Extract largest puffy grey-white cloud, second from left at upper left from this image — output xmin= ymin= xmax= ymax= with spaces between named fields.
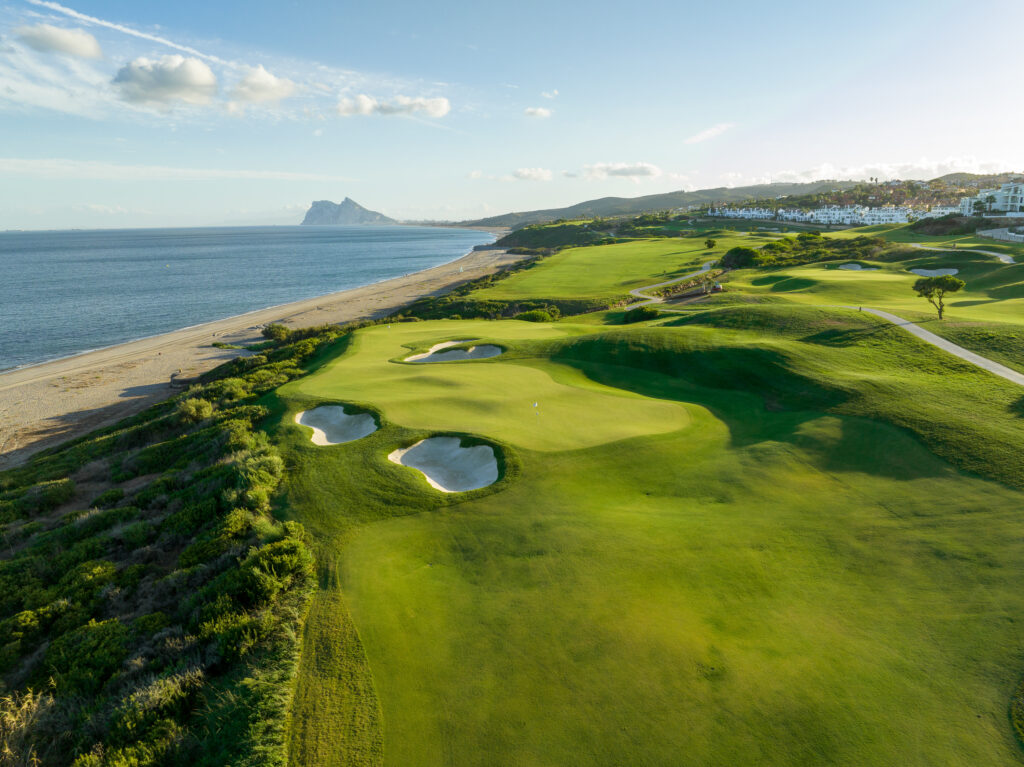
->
xmin=113 ymin=54 xmax=217 ymax=103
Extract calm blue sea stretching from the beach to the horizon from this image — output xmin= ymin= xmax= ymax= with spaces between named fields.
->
xmin=0 ymin=226 xmax=494 ymax=370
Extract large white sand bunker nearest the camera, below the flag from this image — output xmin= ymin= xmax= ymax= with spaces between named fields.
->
xmin=387 ymin=437 xmax=498 ymax=493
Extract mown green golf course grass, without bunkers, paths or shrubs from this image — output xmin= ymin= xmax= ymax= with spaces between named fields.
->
xmin=268 ymin=223 xmax=1024 ymax=767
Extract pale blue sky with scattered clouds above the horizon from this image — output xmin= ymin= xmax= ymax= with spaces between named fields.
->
xmin=0 ymin=0 xmax=1024 ymax=229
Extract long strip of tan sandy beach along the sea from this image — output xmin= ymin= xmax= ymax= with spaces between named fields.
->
xmin=0 ymin=242 xmax=523 ymax=469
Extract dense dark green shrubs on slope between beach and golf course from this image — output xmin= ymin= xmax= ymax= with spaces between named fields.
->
xmin=0 ymin=321 xmax=327 ymax=767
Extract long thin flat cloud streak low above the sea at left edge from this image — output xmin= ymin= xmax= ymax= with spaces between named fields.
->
xmin=0 ymin=158 xmax=352 ymax=181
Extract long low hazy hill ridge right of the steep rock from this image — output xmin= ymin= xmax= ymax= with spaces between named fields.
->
xmin=460 ymin=180 xmax=858 ymax=228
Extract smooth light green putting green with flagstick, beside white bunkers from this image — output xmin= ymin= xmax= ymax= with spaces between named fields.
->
xmin=282 ymin=321 xmax=689 ymax=451
